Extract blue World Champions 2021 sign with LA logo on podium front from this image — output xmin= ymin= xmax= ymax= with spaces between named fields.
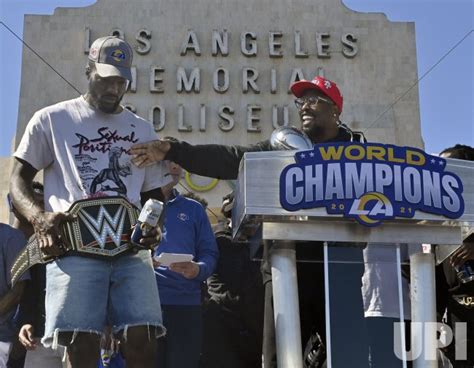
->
xmin=280 ymin=143 xmax=464 ymax=226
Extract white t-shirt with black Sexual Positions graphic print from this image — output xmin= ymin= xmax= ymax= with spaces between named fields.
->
xmin=14 ymin=97 xmax=171 ymax=211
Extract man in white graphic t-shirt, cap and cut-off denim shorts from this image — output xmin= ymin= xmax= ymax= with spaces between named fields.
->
xmin=10 ymin=36 xmax=170 ymax=368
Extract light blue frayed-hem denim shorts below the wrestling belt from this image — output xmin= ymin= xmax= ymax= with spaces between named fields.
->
xmin=42 ymin=250 xmax=166 ymax=349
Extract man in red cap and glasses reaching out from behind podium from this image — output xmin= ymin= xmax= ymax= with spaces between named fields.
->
xmin=131 ymin=76 xmax=368 ymax=368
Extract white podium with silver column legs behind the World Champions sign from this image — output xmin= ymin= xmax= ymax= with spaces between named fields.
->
xmin=232 ymin=151 xmax=474 ymax=368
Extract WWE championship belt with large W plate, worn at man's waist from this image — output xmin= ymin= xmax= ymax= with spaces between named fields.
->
xmin=11 ymin=197 xmax=139 ymax=285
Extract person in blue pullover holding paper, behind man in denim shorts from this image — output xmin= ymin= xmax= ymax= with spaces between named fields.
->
xmin=154 ymin=157 xmax=219 ymax=368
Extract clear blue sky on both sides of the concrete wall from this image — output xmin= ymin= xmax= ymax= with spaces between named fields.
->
xmin=0 ymin=0 xmax=474 ymax=156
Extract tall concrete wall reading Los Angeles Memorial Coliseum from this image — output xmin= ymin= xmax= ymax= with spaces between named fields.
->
xmin=13 ymin=0 xmax=423 ymax=211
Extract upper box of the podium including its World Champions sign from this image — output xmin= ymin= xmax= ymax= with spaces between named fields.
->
xmin=233 ymin=143 xmax=474 ymax=244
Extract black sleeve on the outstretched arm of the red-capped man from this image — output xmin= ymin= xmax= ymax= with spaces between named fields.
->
xmin=166 ymin=140 xmax=271 ymax=180
